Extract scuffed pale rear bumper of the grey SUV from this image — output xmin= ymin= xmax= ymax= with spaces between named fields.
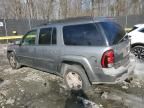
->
xmin=92 ymin=61 xmax=135 ymax=84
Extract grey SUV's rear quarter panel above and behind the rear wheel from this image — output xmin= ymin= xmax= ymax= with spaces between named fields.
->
xmin=61 ymin=46 xmax=110 ymax=81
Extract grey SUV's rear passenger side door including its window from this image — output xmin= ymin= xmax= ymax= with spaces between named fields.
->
xmin=35 ymin=27 xmax=59 ymax=72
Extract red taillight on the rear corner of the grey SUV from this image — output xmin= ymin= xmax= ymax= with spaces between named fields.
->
xmin=101 ymin=50 xmax=114 ymax=68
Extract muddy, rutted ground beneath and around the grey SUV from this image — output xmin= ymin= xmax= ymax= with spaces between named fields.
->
xmin=0 ymin=44 xmax=144 ymax=108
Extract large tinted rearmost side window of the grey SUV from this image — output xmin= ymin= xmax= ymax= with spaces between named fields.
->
xmin=63 ymin=24 xmax=106 ymax=46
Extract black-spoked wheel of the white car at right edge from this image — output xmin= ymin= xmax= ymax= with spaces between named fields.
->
xmin=131 ymin=45 xmax=144 ymax=61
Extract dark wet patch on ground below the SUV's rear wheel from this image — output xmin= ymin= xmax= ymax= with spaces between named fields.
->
xmin=65 ymin=90 xmax=88 ymax=108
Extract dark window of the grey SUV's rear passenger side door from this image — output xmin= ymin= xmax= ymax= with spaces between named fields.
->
xmin=39 ymin=28 xmax=56 ymax=45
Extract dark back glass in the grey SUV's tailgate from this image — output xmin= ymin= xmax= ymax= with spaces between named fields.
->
xmin=100 ymin=22 xmax=125 ymax=45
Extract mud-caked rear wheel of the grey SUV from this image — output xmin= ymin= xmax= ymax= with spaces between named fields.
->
xmin=64 ymin=65 xmax=91 ymax=90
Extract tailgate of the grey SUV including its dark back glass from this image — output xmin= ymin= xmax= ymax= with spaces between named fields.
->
xmin=100 ymin=22 xmax=130 ymax=67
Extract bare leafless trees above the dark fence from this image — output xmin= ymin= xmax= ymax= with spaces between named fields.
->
xmin=0 ymin=0 xmax=144 ymax=20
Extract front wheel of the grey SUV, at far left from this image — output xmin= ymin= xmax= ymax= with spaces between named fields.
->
xmin=8 ymin=52 xmax=21 ymax=69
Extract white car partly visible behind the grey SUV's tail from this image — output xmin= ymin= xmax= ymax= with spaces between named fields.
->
xmin=128 ymin=24 xmax=144 ymax=60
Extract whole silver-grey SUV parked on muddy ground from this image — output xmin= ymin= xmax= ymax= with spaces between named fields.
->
xmin=7 ymin=17 xmax=134 ymax=89
